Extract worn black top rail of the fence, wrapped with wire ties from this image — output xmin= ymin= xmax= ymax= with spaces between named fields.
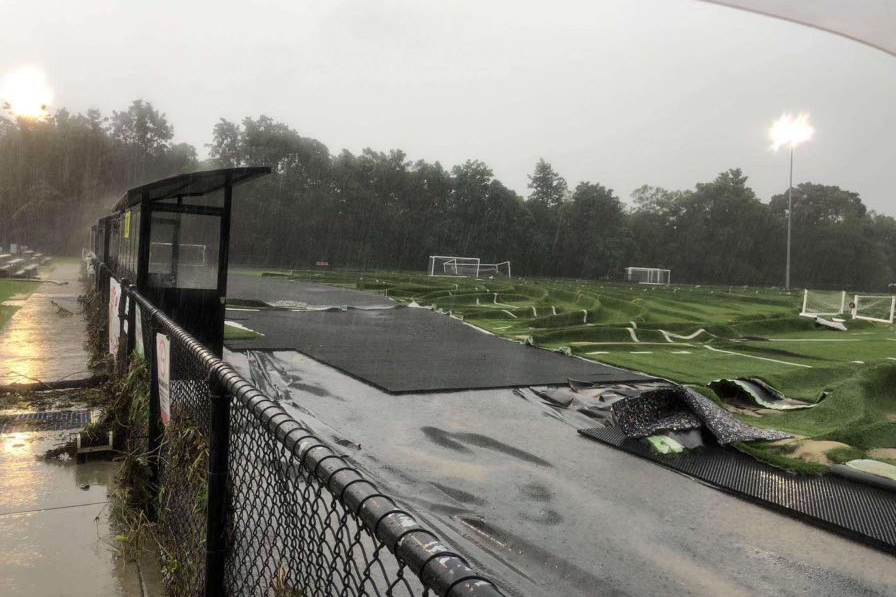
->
xmin=93 ymin=259 xmax=503 ymax=597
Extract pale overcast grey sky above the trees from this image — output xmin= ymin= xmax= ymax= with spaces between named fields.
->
xmin=0 ymin=0 xmax=896 ymax=215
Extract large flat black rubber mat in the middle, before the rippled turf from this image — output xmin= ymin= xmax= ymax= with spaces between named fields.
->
xmin=225 ymin=308 xmax=651 ymax=393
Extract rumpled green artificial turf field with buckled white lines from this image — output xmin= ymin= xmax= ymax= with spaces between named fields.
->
xmin=266 ymin=271 xmax=896 ymax=473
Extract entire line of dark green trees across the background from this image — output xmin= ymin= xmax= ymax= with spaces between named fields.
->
xmin=0 ymin=100 xmax=896 ymax=290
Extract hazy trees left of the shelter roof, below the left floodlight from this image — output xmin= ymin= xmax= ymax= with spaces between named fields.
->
xmin=0 ymin=101 xmax=197 ymax=252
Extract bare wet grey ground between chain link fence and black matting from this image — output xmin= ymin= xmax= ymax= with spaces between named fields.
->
xmin=227 ymin=352 xmax=896 ymax=596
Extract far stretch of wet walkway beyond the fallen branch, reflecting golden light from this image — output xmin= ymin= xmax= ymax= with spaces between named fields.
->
xmin=0 ymin=259 xmax=91 ymax=386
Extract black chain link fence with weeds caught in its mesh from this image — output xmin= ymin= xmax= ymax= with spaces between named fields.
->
xmin=94 ymin=262 xmax=501 ymax=597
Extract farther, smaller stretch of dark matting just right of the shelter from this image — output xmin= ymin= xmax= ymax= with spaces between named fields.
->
xmin=227 ymin=274 xmax=395 ymax=308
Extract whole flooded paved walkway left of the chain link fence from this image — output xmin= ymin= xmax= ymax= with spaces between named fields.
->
xmin=0 ymin=261 xmax=161 ymax=597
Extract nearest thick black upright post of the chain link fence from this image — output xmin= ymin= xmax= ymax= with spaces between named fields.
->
xmin=205 ymin=370 xmax=230 ymax=597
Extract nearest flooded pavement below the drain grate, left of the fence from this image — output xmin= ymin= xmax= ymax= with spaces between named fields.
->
xmin=0 ymin=411 xmax=160 ymax=597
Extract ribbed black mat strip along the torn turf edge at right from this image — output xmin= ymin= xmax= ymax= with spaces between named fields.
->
xmin=579 ymin=427 xmax=896 ymax=553
